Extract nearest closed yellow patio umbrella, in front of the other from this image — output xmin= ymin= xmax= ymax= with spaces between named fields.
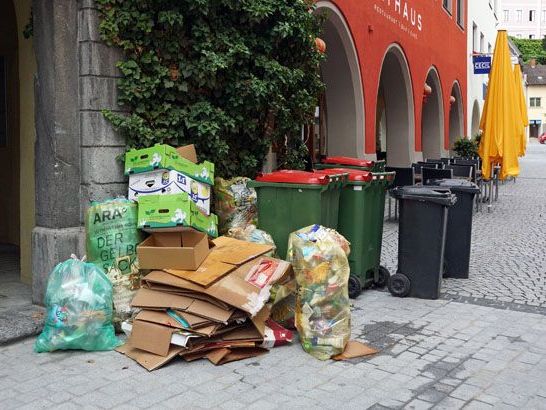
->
xmin=478 ymin=30 xmax=522 ymax=179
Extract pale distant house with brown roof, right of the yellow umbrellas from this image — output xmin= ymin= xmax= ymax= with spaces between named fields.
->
xmin=523 ymin=60 xmax=546 ymax=138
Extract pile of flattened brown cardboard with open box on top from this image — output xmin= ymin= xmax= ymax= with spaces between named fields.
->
xmin=117 ymin=235 xmax=292 ymax=370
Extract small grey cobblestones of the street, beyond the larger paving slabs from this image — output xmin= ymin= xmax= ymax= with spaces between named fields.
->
xmin=383 ymin=143 xmax=546 ymax=313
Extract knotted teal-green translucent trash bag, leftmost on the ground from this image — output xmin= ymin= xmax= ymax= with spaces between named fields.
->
xmin=34 ymin=259 xmax=120 ymax=353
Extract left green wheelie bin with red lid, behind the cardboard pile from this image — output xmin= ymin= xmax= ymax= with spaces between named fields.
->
xmin=248 ymin=170 xmax=347 ymax=258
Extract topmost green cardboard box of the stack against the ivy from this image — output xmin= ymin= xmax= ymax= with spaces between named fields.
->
xmin=125 ymin=144 xmax=214 ymax=185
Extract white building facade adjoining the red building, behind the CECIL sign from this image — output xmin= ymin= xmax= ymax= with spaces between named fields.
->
xmin=466 ymin=0 xmax=498 ymax=137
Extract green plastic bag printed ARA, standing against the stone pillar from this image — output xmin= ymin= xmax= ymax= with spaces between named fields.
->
xmin=85 ymin=198 xmax=144 ymax=272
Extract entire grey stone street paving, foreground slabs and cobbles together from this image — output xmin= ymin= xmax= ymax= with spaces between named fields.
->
xmin=0 ymin=146 xmax=546 ymax=409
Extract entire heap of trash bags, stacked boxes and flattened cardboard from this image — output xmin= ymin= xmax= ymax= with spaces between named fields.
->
xmin=35 ymin=145 xmax=373 ymax=371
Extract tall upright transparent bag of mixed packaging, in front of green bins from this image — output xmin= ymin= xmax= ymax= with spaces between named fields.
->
xmin=288 ymin=225 xmax=351 ymax=360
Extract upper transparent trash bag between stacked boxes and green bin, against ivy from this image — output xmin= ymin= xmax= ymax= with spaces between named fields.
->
xmin=214 ymin=177 xmax=258 ymax=235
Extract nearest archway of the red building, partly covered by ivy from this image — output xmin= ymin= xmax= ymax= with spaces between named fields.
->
xmin=316 ymin=1 xmax=365 ymax=157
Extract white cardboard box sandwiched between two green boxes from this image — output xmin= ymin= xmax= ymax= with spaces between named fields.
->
xmin=128 ymin=169 xmax=212 ymax=215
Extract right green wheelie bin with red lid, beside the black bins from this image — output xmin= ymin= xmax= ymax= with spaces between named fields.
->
xmin=316 ymin=168 xmax=395 ymax=298
